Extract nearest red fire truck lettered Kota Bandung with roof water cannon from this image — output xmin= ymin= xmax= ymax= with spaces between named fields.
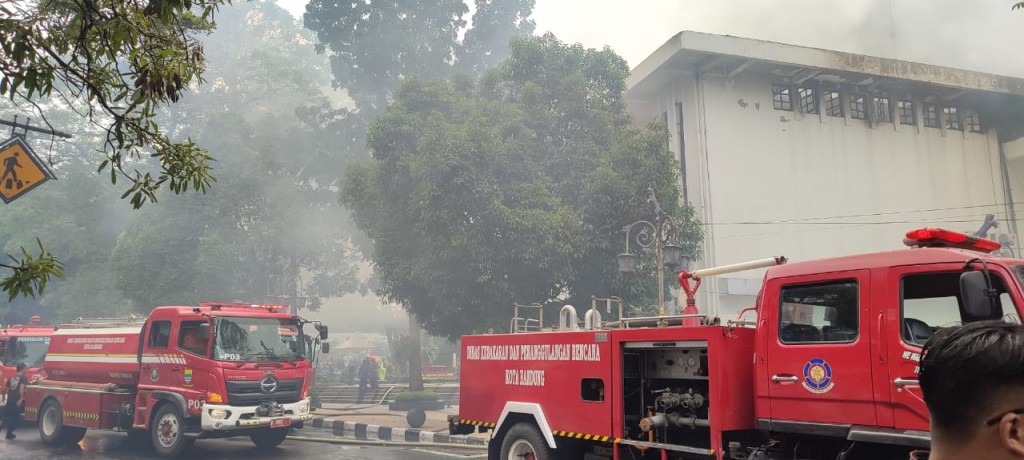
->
xmin=450 ymin=228 xmax=1024 ymax=460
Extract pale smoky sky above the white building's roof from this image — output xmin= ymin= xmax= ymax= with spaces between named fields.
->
xmin=278 ymin=0 xmax=1024 ymax=77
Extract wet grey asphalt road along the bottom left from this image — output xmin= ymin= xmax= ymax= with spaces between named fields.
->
xmin=0 ymin=425 xmax=486 ymax=460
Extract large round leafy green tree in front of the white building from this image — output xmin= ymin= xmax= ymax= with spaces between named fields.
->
xmin=342 ymin=35 xmax=701 ymax=338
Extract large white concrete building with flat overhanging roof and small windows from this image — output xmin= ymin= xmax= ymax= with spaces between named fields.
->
xmin=627 ymin=32 xmax=1024 ymax=318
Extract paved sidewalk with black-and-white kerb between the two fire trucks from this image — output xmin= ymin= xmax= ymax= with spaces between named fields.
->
xmin=307 ymin=404 xmax=490 ymax=446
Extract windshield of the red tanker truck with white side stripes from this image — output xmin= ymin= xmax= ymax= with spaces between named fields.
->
xmin=213 ymin=317 xmax=306 ymax=363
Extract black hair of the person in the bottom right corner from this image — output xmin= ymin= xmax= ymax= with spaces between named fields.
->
xmin=920 ymin=322 xmax=1024 ymax=442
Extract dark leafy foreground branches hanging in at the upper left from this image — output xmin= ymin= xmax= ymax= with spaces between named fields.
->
xmin=0 ymin=0 xmax=228 ymax=298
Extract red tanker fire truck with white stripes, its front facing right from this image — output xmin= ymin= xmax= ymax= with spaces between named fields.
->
xmin=25 ymin=302 xmax=327 ymax=457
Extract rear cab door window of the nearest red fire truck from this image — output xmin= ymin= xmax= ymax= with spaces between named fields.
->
xmin=778 ymin=281 xmax=860 ymax=344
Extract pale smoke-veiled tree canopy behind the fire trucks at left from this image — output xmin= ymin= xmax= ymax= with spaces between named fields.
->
xmin=0 ymin=2 xmax=358 ymax=323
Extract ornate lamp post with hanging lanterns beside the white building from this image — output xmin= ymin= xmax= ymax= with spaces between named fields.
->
xmin=617 ymin=187 xmax=687 ymax=317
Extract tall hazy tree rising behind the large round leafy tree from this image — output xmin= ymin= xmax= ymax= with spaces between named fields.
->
xmin=303 ymin=0 xmax=534 ymax=391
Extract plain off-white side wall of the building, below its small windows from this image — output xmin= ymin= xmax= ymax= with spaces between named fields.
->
xmin=631 ymin=70 xmax=1007 ymax=318
